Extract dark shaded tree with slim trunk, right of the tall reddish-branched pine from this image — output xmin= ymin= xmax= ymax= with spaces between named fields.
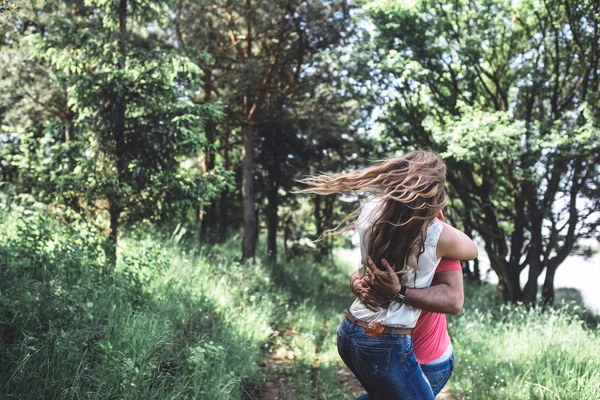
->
xmin=256 ymin=65 xmax=364 ymax=259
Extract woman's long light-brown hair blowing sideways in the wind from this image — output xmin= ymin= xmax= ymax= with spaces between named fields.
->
xmin=300 ymin=150 xmax=446 ymax=273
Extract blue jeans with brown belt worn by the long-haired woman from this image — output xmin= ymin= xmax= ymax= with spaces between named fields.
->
xmin=337 ymin=318 xmax=434 ymax=400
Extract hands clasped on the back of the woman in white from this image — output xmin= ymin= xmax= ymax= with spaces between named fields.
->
xmin=351 ymin=257 xmax=400 ymax=312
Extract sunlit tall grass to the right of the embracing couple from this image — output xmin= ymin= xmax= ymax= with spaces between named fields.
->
xmin=448 ymin=285 xmax=600 ymax=400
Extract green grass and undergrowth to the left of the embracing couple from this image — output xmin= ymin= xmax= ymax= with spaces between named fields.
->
xmin=0 ymin=204 xmax=348 ymax=400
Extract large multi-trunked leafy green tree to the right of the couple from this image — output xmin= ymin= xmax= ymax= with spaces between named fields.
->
xmin=367 ymin=0 xmax=600 ymax=303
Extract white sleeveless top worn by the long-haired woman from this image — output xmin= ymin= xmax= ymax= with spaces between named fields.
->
xmin=350 ymin=198 xmax=443 ymax=328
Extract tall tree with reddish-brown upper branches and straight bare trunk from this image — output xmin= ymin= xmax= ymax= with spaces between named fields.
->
xmin=175 ymin=0 xmax=349 ymax=259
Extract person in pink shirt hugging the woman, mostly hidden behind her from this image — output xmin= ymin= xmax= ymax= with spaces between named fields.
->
xmin=351 ymin=250 xmax=464 ymax=400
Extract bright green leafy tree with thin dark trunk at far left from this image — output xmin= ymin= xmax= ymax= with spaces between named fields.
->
xmin=3 ymin=0 xmax=226 ymax=266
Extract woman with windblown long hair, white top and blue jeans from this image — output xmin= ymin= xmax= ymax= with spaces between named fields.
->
xmin=302 ymin=151 xmax=477 ymax=400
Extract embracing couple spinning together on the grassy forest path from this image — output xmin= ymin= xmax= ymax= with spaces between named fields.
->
xmin=303 ymin=151 xmax=477 ymax=400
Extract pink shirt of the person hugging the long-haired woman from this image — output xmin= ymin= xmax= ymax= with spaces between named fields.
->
xmin=412 ymin=258 xmax=462 ymax=364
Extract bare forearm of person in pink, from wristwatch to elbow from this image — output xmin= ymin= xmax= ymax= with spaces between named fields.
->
xmin=404 ymin=283 xmax=464 ymax=315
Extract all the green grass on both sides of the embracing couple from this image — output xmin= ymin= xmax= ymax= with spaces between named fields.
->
xmin=0 ymin=205 xmax=600 ymax=400
